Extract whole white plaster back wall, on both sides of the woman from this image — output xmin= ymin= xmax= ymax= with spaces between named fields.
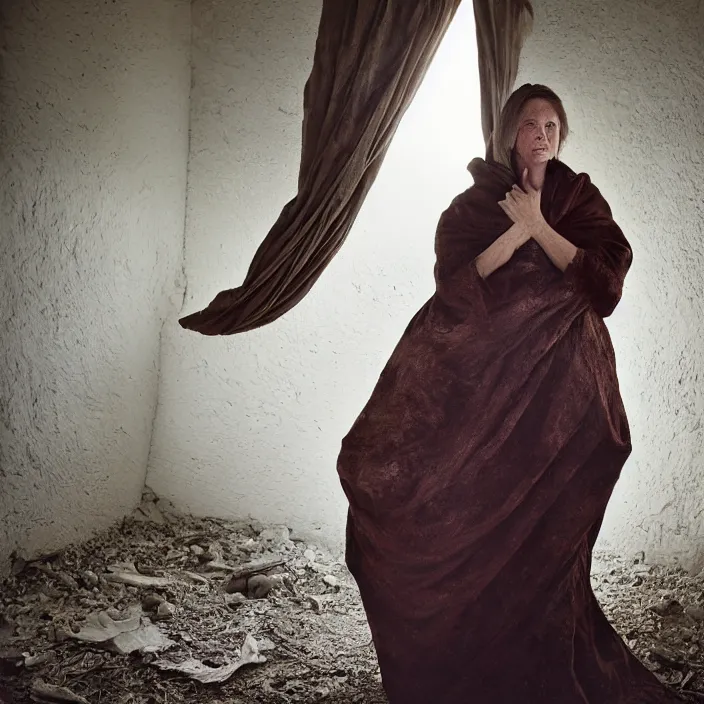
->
xmin=149 ymin=0 xmax=704 ymax=567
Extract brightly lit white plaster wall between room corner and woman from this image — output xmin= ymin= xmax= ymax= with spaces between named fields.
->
xmin=148 ymin=0 xmax=481 ymax=544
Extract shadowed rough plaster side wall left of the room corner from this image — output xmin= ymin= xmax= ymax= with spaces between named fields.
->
xmin=0 ymin=0 xmax=190 ymax=570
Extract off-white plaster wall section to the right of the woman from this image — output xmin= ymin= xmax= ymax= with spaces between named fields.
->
xmin=521 ymin=0 xmax=704 ymax=569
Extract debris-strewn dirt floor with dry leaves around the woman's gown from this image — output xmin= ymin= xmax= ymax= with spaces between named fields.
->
xmin=0 ymin=494 xmax=704 ymax=704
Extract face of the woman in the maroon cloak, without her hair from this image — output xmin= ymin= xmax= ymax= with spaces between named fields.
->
xmin=515 ymin=98 xmax=560 ymax=169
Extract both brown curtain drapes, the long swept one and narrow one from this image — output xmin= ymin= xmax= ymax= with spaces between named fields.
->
xmin=179 ymin=0 xmax=532 ymax=335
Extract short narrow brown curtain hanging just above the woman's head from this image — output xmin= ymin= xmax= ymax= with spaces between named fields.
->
xmin=474 ymin=0 xmax=533 ymax=158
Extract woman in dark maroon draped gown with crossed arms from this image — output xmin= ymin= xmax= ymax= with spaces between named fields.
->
xmin=338 ymin=84 xmax=680 ymax=704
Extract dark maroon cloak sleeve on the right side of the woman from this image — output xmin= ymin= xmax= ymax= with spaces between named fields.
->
xmin=555 ymin=176 xmax=633 ymax=318
